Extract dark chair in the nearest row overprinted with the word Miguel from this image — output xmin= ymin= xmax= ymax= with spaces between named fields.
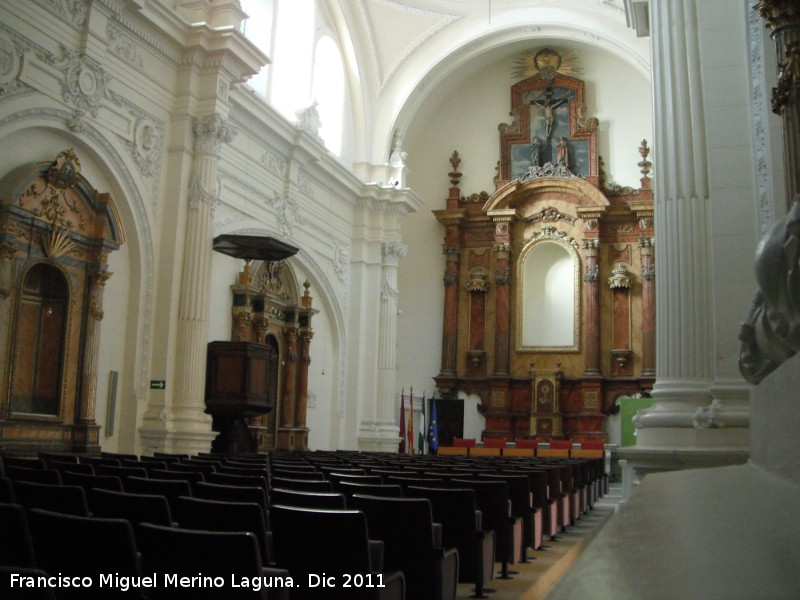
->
xmin=28 ymin=509 xmax=145 ymax=600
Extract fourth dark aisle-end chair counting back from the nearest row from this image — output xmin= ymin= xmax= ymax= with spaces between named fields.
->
xmin=450 ymin=479 xmax=522 ymax=579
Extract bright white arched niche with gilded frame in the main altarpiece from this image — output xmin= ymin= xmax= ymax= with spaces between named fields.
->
xmin=516 ymin=238 xmax=581 ymax=352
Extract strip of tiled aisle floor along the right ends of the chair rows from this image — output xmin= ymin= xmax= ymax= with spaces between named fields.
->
xmin=456 ymin=485 xmax=621 ymax=600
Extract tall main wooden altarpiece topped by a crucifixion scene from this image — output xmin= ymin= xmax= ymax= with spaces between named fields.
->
xmin=434 ymin=61 xmax=655 ymax=441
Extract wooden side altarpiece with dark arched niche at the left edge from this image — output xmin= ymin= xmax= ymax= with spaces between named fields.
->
xmin=0 ymin=149 xmax=125 ymax=453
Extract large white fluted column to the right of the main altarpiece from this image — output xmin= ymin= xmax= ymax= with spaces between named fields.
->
xmin=635 ymin=0 xmax=714 ymax=446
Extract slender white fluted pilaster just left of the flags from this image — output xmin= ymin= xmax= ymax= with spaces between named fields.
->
xmin=358 ymin=242 xmax=408 ymax=452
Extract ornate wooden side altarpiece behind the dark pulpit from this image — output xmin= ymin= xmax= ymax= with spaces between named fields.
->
xmin=207 ymin=239 xmax=317 ymax=452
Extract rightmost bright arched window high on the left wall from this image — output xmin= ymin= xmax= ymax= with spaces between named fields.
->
xmin=311 ymin=36 xmax=345 ymax=155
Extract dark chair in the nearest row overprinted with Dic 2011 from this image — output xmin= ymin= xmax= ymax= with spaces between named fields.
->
xmin=271 ymin=505 xmax=405 ymax=600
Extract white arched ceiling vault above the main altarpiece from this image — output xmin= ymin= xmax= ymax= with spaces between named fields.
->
xmin=338 ymin=0 xmax=650 ymax=164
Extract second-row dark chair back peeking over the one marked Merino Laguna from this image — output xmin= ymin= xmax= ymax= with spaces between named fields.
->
xmin=174 ymin=496 xmax=274 ymax=565
